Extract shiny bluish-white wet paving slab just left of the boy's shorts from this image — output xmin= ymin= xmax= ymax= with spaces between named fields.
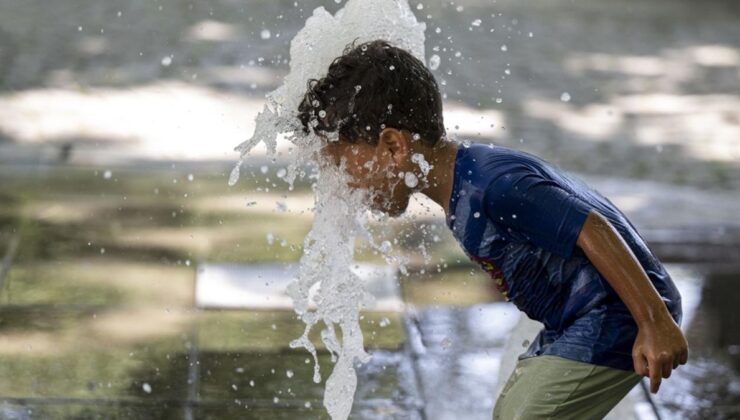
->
xmin=407 ymin=303 xmax=519 ymax=420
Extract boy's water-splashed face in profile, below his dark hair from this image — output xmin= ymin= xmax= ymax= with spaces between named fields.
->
xmin=321 ymin=131 xmax=413 ymax=217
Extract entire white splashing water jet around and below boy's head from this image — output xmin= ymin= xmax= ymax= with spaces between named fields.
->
xmin=229 ymin=0 xmax=426 ymax=420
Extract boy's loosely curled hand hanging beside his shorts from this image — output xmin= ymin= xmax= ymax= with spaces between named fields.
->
xmin=632 ymin=317 xmax=689 ymax=394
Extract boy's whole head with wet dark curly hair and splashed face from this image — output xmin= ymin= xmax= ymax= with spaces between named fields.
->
xmin=298 ymin=40 xmax=446 ymax=216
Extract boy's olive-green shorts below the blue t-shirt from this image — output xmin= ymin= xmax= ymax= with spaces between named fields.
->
xmin=493 ymin=356 xmax=640 ymax=420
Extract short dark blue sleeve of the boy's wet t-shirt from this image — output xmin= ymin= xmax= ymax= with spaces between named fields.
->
xmin=484 ymin=168 xmax=592 ymax=258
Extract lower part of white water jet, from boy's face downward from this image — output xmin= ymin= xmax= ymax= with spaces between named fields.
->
xmin=288 ymin=163 xmax=374 ymax=418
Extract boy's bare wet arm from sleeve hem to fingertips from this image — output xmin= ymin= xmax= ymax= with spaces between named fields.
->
xmin=577 ymin=210 xmax=688 ymax=393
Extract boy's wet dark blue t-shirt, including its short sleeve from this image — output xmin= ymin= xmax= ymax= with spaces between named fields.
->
xmin=447 ymin=144 xmax=681 ymax=370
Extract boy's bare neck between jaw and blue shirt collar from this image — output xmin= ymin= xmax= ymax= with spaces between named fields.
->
xmin=421 ymin=140 xmax=459 ymax=214
